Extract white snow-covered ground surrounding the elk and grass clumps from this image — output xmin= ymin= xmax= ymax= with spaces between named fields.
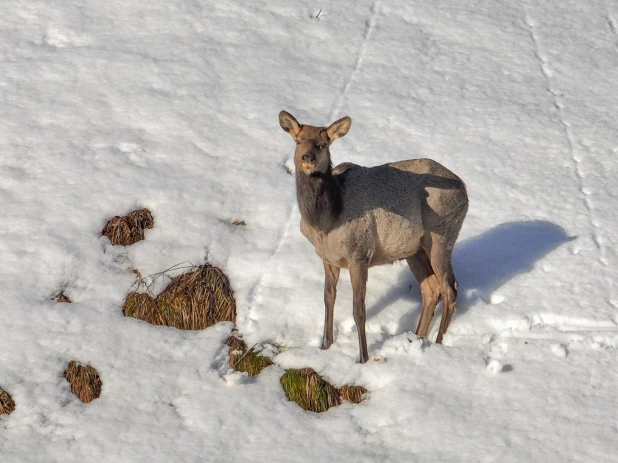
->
xmin=0 ymin=0 xmax=618 ymax=463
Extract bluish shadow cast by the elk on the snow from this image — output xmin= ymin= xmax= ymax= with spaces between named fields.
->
xmin=367 ymin=220 xmax=574 ymax=334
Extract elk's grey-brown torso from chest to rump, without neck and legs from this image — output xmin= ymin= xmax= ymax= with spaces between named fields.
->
xmin=301 ymin=159 xmax=468 ymax=267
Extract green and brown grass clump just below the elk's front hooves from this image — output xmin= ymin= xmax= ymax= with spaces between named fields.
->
xmin=281 ymin=368 xmax=367 ymax=413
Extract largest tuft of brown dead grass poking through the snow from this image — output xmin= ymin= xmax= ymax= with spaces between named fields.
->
xmin=122 ymin=264 xmax=236 ymax=330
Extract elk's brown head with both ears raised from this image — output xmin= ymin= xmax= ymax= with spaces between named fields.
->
xmin=279 ymin=111 xmax=352 ymax=175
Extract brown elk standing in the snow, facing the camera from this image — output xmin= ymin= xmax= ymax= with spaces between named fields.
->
xmin=279 ymin=111 xmax=468 ymax=363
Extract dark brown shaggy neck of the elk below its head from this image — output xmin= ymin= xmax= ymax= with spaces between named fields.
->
xmin=296 ymin=166 xmax=343 ymax=233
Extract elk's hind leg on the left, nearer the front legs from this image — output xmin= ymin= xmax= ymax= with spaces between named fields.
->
xmin=406 ymin=249 xmax=441 ymax=338
